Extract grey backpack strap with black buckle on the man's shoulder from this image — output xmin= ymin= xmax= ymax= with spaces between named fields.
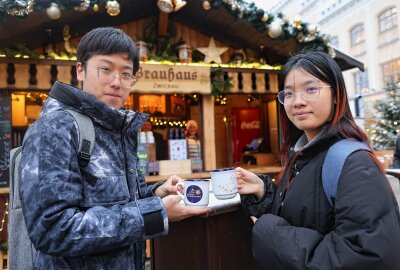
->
xmin=65 ymin=109 xmax=95 ymax=168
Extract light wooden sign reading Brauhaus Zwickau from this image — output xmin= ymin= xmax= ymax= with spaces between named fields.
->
xmin=132 ymin=63 xmax=211 ymax=94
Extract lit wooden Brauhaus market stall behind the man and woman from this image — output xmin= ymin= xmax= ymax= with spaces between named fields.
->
xmin=0 ymin=0 xmax=363 ymax=269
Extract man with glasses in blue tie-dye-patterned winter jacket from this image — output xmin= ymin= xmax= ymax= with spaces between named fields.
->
xmin=19 ymin=28 xmax=207 ymax=269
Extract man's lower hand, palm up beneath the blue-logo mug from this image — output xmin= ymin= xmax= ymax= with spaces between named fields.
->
xmin=160 ymin=196 xmax=210 ymax=222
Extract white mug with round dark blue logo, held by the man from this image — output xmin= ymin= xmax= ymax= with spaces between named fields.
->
xmin=176 ymin=179 xmax=210 ymax=208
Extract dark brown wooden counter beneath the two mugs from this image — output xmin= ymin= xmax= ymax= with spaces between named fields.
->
xmin=151 ymin=185 xmax=259 ymax=270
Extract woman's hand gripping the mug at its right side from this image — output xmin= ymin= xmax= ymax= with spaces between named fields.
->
xmin=236 ymin=167 xmax=265 ymax=200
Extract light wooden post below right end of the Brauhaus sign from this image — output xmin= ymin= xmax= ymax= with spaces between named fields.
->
xmin=202 ymin=95 xmax=217 ymax=171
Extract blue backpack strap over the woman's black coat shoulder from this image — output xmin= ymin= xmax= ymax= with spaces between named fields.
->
xmin=322 ymin=139 xmax=372 ymax=207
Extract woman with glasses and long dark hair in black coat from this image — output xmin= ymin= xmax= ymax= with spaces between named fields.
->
xmin=236 ymin=51 xmax=400 ymax=270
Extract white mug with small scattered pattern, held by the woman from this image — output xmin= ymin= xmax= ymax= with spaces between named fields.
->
xmin=211 ymin=168 xmax=238 ymax=200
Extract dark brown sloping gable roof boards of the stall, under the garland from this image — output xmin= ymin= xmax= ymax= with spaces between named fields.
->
xmin=0 ymin=0 xmax=364 ymax=70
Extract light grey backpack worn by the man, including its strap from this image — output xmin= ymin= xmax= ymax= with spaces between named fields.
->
xmin=8 ymin=110 xmax=95 ymax=270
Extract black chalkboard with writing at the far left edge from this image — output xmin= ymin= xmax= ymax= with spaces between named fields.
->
xmin=0 ymin=93 xmax=11 ymax=187
